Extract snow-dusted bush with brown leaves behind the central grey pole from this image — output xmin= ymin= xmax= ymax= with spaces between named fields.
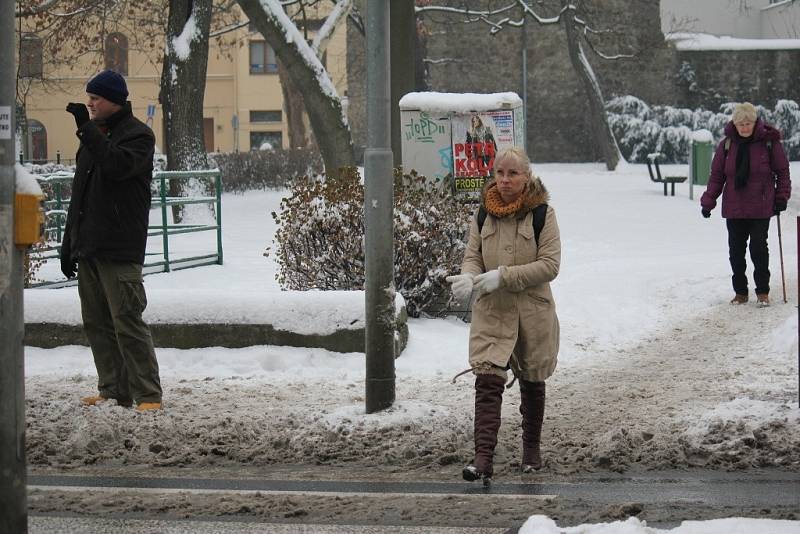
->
xmin=265 ymin=168 xmax=472 ymax=317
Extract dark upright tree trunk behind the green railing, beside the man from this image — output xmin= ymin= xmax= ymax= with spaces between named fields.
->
xmin=158 ymin=0 xmax=212 ymax=222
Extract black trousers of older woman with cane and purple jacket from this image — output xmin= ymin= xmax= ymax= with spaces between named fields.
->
xmin=726 ymin=219 xmax=770 ymax=295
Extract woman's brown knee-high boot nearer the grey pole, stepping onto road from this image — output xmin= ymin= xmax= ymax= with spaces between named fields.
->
xmin=462 ymin=374 xmax=506 ymax=482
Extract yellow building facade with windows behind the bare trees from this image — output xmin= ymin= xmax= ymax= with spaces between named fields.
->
xmin=21 ymin=7 xmax=347 ymax=162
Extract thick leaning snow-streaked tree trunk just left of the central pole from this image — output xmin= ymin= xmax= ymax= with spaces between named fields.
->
xmin=238 ymin=0 xmax=355 ymax=174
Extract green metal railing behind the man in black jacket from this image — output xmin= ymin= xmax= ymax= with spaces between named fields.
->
xmin=30 ymin=169 xmax=222 ymax=287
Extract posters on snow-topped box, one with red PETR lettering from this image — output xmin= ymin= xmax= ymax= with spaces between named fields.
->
xmin=451 ymin=109 xmax=514 ymax=192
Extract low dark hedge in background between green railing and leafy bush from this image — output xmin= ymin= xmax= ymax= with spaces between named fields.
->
xmin=214 ymin=148 xmax=323 ymax=193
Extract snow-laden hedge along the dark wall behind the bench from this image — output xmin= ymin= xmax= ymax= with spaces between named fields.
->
xmin=606 ymin=96 xmax=800 ymax=163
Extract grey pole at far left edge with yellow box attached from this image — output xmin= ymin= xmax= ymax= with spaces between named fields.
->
xmin=0 ymin=0 xmax=28 ymax=534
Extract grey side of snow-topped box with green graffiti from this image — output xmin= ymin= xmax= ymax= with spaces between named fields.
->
xmin=400 ymin=109 xmax=453 ymax=180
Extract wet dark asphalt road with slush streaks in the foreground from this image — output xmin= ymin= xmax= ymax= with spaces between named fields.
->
xmin=28 ymin=471 xmax=800 ymax=534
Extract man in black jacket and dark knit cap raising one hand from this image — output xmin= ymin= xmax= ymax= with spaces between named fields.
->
xmin=61 ymin=70 xmax=161 ymax=411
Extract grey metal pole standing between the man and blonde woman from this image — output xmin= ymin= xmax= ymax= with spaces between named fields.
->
xmin=364 ymin=0 xmax=395 ymax=413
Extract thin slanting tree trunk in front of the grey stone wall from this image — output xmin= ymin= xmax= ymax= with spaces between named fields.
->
xmin=562 ymin=5 xmax=621 ymax=171
